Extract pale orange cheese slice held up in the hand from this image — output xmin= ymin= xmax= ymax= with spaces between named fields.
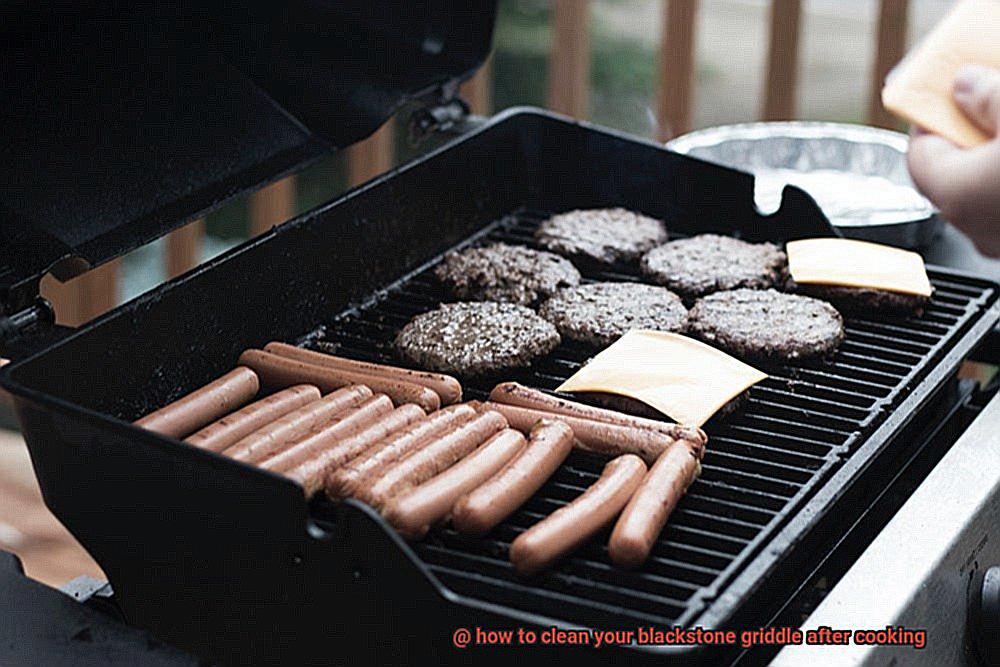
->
xmin=882 ymin=0 xmax=1000 ymax=148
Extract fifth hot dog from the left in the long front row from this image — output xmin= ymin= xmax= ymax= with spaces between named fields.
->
xmin=284 ymin=405 xmax=427 ymax=498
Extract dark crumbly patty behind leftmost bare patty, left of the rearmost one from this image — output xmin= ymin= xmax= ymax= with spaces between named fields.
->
xmin=435 ymin=243 xmax=580 ymax=306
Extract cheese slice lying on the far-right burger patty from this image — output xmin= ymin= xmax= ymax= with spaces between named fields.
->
xmin=785 ymin=238 xmax=933 ymax=296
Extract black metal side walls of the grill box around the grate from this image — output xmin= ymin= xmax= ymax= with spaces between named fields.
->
xmin=0 ymin=109 xmax=1000 ymax=664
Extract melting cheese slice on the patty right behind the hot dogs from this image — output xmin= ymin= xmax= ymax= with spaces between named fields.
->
xmin=558 ymin=329 xmax=767 ymax=426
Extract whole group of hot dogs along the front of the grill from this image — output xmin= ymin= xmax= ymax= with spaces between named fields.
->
xmin=136 ymin=343 xmax=706 ymax=574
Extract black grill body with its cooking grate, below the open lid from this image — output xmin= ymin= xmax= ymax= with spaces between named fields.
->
xmin=2 ymin=110 xmax=998 ymax=662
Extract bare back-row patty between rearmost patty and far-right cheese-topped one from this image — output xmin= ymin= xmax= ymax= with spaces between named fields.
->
xmin=641 ymin=234 xmax=788 ymax=299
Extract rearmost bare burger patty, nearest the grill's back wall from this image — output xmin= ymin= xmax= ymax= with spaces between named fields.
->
xmin=535 ymin=208 xmax=667 ymax=265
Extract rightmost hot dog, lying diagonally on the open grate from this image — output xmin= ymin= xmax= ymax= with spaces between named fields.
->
xmin=608 ymin=440 xmax=705 ymax=567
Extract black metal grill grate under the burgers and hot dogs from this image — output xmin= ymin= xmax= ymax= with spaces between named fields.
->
xmin=306 ymin=210 xmax=992 ymax=628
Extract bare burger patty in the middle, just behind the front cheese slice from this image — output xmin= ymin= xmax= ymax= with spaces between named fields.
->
xmin=538 ymin=283 xmax=687 ymax=347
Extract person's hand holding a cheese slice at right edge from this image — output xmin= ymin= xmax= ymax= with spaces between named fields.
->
xmin=907 ymin=66 xmax=1000 ymax=256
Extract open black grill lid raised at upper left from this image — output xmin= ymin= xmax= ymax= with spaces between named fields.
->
xmin=0 ymin=0 xmax=496 ymax=315
